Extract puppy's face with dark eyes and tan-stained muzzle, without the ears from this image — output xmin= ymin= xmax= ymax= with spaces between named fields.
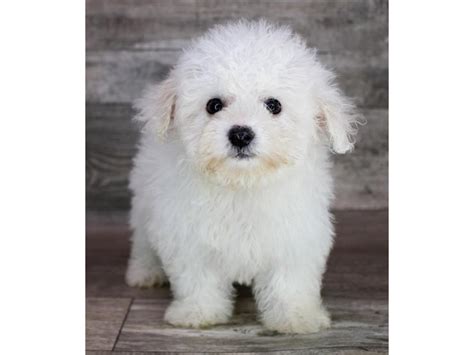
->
xmin=175 ymin=62 xmax=315 ymax=185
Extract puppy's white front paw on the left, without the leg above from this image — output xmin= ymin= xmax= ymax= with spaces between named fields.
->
xmin=165 ymin=301 xmax=231 ymax=328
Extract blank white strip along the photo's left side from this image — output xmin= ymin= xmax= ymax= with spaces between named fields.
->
xmin=0 ymin=1 xmax=85 ymax=354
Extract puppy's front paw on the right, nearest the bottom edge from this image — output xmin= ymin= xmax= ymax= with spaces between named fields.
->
xmin=262 ymin=306 xmax=331 ymax=334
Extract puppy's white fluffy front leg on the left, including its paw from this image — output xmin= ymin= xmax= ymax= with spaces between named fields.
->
xmin=165 ymin=262 xmax=233 ymax=328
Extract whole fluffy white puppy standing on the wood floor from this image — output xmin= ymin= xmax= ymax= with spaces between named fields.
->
xmin=126 ymin=21 xmax=357 ymax=333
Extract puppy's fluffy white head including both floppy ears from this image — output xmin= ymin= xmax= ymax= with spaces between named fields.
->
xmin=137 ymin=21 xmax=357 ymax=186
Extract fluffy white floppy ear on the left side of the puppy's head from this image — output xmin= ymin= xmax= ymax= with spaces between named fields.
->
xmin=134 ymin=71 xmax=176 ymax=138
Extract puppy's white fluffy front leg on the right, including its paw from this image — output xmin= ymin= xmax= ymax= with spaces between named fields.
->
xmin=254 ymin=269 xmax=331 ymax=333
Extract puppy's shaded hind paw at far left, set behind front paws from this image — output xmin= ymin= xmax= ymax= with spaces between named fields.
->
xmin=125 ymin=259 xmax=168 ymax=288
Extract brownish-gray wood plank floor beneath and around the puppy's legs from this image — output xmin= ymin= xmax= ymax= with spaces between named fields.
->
xmin=86 ymin=210 xmax=388 ymax=355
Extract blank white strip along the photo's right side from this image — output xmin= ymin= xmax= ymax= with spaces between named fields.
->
xmin=389 ymin=1 xmax=474 ymax=355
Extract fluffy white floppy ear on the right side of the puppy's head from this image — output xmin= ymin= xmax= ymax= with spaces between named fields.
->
xmin=316 ymin=70 xmax=363 ymax=154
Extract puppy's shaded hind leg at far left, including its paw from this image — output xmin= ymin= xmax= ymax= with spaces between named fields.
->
xmin=125 ymin=228 xmax=168 ymax=287
